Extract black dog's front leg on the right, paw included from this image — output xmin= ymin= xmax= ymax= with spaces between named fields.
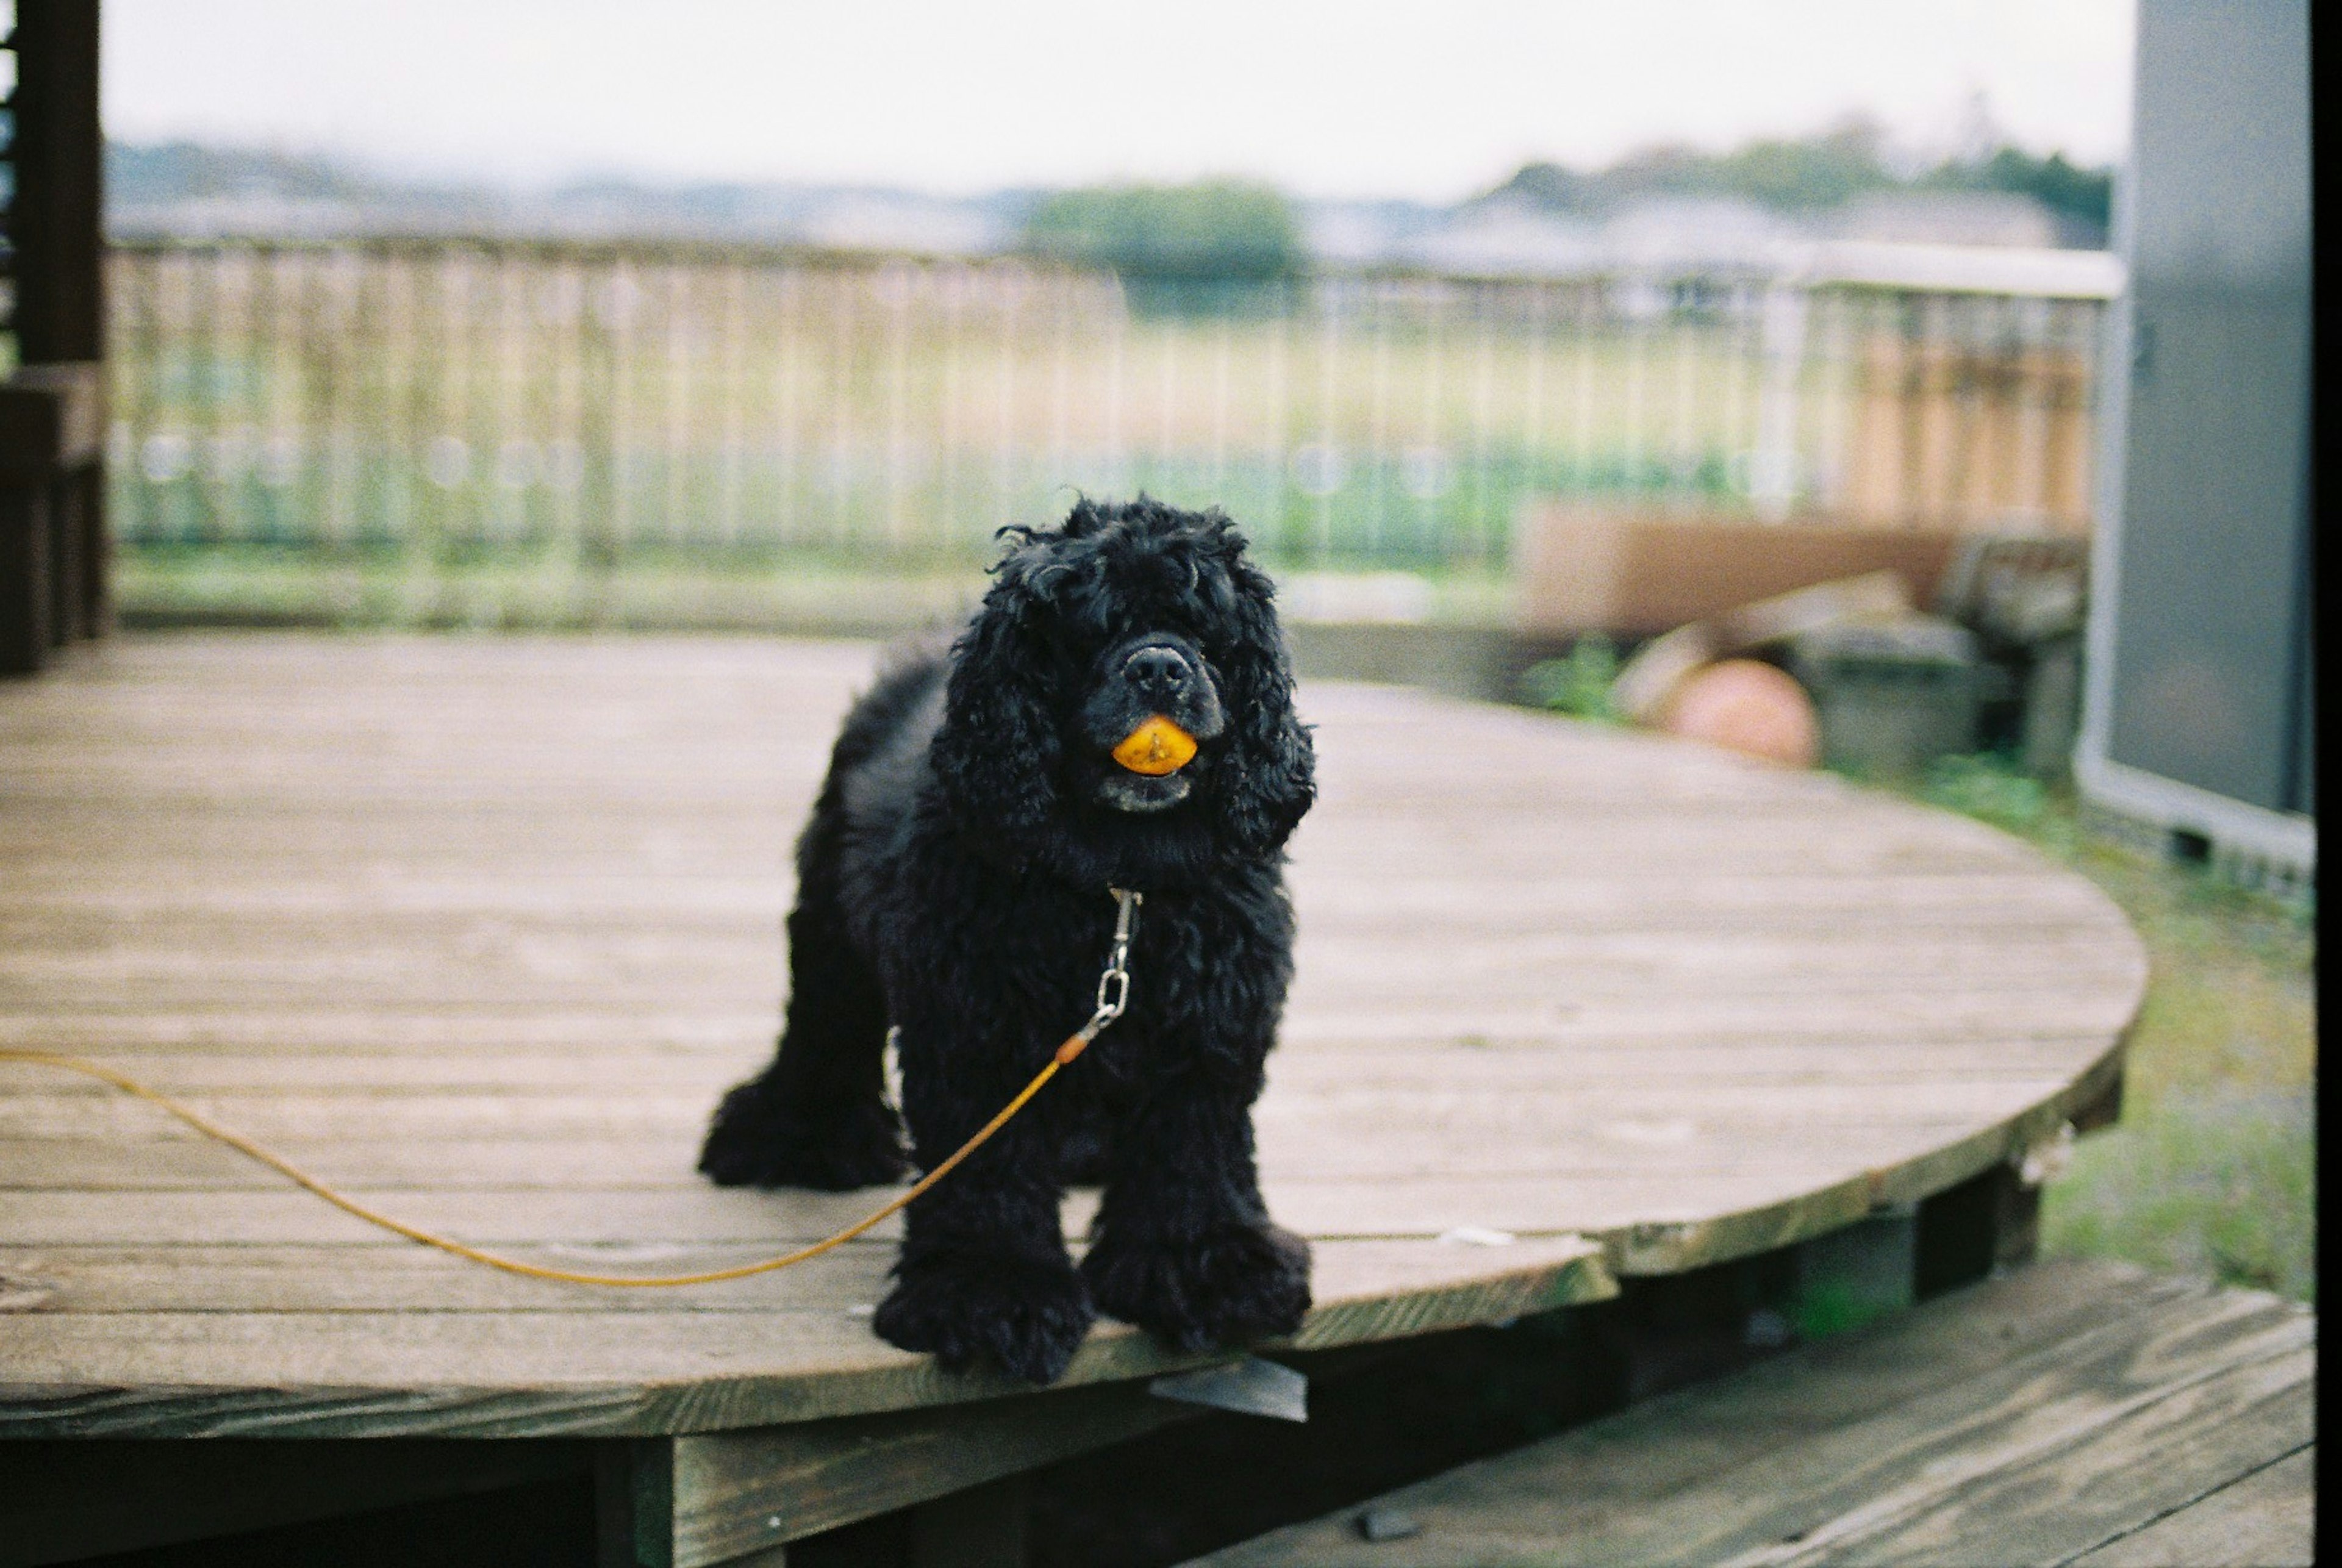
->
xmin=1082 ymin=1048 xmax=1309 ymax=1350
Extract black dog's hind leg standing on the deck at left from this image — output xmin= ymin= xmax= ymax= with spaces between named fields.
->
xmin=700 ymin=879 xmax=904 ymax=1191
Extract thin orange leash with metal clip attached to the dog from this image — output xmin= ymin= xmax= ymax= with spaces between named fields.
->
xmin=0 ymin=887 xmax=1138 ymax=1289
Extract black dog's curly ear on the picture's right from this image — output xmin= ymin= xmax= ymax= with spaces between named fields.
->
xmin=1218 ymin=559 xmax=1316 ymax=854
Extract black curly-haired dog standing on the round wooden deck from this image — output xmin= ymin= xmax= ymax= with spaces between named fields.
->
xmin=700 ymin=496 xmax=1316 ymax=1383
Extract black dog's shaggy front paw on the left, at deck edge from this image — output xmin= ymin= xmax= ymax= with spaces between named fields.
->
xmin=871 ymin=1250 xmax=1096 ymax=1383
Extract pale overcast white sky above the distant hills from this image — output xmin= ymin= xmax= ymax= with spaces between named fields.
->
xmin=103 ymin=0 xmax=2133 ymax=201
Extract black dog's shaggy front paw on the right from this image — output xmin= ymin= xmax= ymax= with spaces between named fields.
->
xmin=1082 ymin=1224 xmax=1309 ymax=1350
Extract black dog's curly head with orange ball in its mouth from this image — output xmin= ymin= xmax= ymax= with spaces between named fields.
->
xmin=934 ymin=496 xmax=1316 ymax=889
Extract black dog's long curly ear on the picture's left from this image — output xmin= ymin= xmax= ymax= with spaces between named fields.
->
xmin=929 ymin=553 xmax=1063 ymax=850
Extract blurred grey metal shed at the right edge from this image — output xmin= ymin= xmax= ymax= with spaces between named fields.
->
xmin=2075 ymin=0 xmax=2316 ymax=882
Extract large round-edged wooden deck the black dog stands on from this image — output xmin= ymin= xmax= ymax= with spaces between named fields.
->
xmin=0 ymin=634 xmax=2145 ymax=1561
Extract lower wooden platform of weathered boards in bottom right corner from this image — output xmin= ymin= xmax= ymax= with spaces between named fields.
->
xmin=1197 ymin=1261 xmax=2316 ymax=1568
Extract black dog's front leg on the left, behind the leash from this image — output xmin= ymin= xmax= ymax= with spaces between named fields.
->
xmin=871 ymin=1018 xmax=1096 ymax=1383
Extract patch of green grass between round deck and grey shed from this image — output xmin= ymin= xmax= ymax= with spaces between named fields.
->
xmin=1909 ymin=758 xmax=2319 ymax=1303
